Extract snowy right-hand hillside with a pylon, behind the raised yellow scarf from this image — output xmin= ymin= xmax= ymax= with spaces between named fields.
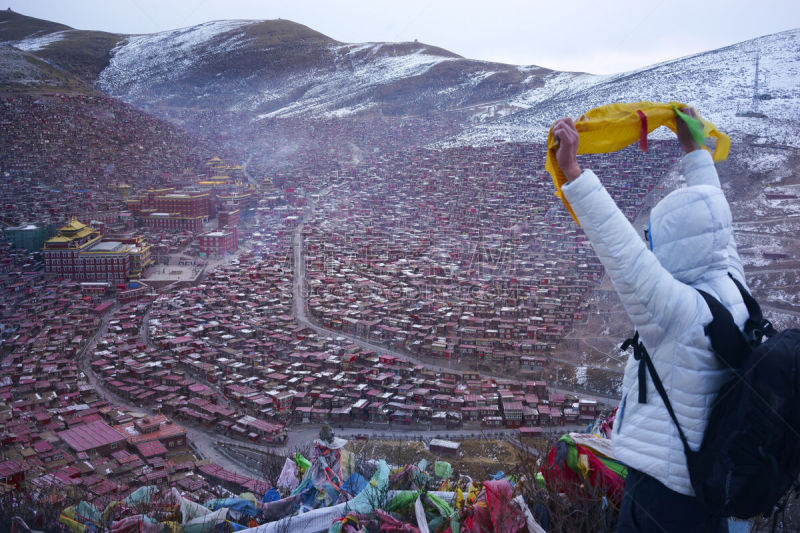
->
xmin=442 ymin=30 xmax=800 ymax=147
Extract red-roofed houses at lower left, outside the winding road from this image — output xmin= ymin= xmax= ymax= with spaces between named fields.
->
xmin=0 ymin=271 xmax=266 ymax=506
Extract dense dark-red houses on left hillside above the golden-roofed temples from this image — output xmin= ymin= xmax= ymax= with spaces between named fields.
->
xmin=0 ymin=94 xmax=210 ymax=230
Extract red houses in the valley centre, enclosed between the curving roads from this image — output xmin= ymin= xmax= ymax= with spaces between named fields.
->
xmin=119 ymin=254 xmax=598 ymax=441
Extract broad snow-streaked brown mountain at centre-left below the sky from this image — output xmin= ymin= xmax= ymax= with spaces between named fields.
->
xmin=94 ymin=20 xmax=549 ymax=117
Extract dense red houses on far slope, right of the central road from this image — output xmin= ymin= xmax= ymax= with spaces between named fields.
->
xmin=303 ymin=143 xmax=677 ymax=368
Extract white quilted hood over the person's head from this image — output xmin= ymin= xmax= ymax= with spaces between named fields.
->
xmin=649 ymin=185 xmax=733 ymax=285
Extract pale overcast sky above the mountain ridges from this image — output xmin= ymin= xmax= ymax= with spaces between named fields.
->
xmin=6 ymin=0 xmax=800 ymax=74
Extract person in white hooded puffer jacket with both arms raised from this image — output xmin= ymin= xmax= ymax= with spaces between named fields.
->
xmin=553 ymin=109 xmax=748 ymax=533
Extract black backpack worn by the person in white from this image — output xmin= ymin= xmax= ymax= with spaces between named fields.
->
xmin=623 ymin=274 xmax=800 ymax=518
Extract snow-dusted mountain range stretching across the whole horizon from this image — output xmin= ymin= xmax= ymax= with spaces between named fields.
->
xmin=0 ymin=8 xmax=800 ymax=147
